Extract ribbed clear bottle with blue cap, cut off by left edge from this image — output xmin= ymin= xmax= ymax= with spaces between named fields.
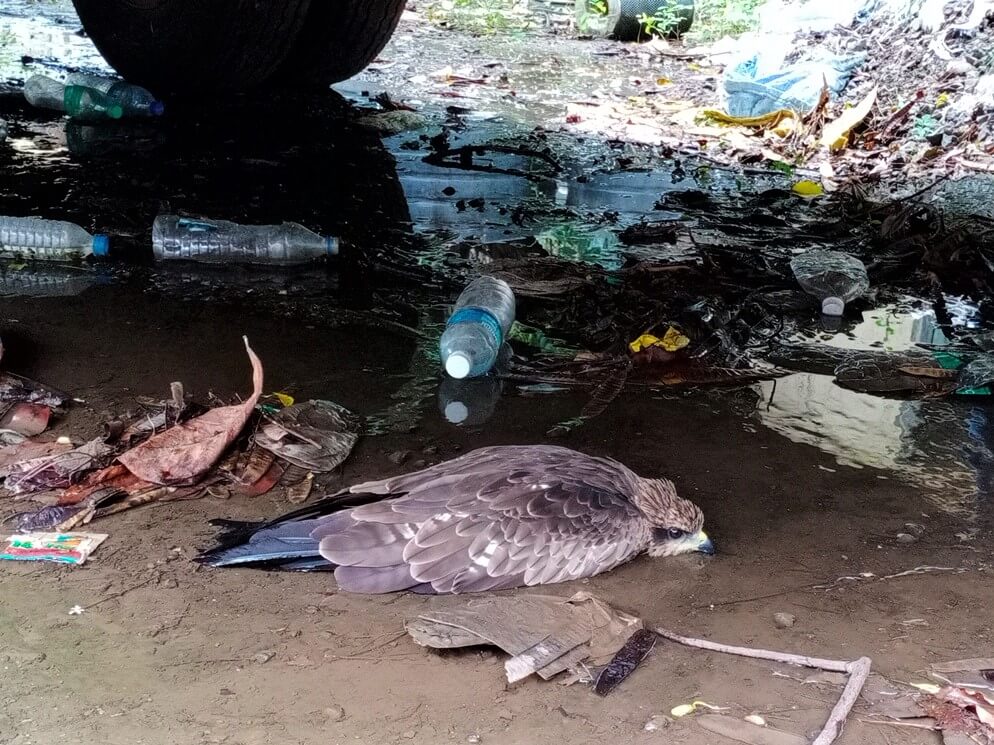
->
xmin=0 ymin=217 xmax=110 ymax=261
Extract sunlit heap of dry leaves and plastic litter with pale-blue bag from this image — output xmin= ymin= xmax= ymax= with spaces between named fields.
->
xmin=565 ymin=0 xmax=994 ymax=186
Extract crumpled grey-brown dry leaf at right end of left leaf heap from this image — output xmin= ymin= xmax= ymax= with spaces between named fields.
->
xmin=255 ymin=401 xmax=362 ymax=473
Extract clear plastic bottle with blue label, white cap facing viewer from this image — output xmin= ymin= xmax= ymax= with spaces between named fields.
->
xmin=439 ymin=277 xmax=514 ymax=378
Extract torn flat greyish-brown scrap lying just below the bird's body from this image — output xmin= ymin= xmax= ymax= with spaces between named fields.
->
xmin=404 ymin=592 xmax=642 ymax=683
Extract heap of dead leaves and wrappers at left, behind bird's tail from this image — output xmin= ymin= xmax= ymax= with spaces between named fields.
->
xmin=0 ymin=339 xmax=362 ymax=563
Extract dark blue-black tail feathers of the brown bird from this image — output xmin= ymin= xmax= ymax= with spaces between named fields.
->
xmin=194 ymin=492 xmax=384 ymax=572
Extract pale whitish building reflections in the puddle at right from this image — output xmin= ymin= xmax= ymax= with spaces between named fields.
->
xmin=757 ymin=298 xmax=994 ymax=517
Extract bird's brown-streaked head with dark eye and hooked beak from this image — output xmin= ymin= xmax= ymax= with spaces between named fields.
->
xmin=636 ymin=479 xmax=714 ymax=556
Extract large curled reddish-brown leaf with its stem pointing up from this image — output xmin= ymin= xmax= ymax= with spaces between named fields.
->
xmin=118 ymin=337 xmax=262 ymax=485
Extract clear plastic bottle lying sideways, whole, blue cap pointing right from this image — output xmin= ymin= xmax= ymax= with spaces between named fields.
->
xmin=152 ymin=215 xmax=338 ymax=266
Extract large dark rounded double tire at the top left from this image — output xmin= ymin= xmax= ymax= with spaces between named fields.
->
xmin=73 ymin=0 xmax=403 ymax=95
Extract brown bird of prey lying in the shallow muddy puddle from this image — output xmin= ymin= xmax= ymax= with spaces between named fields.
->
xmin=199 ymin=445 xmax=714 ymax=593
